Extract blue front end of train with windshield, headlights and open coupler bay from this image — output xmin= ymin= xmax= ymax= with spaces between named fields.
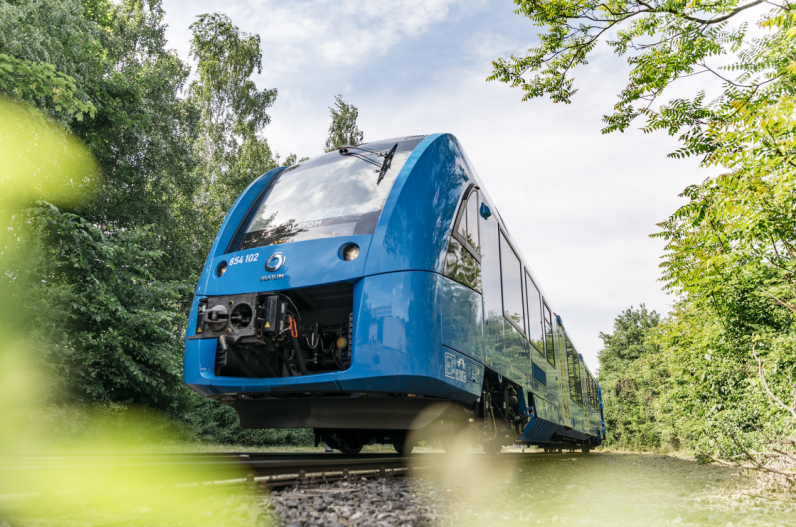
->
xmin=185 ymin=134 xmax=483 ymax=450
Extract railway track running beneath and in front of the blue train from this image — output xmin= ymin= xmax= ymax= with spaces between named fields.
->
xmin=0 ymin=452 xmax=580 ymax=494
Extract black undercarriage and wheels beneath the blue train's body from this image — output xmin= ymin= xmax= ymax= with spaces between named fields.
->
xmin=220 ymin=370 xmax=599 ymax=454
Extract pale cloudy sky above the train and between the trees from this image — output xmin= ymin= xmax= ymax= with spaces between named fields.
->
xmin=164 ymin=0 xmax=709 ymax=372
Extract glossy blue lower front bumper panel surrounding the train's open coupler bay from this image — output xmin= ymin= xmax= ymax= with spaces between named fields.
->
xmin=184 ymin=271 xmax=484 ymax=404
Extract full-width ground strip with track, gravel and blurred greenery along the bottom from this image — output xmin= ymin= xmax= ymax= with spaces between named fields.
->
xmin=0 ymin=451 xmax=796 ymax=527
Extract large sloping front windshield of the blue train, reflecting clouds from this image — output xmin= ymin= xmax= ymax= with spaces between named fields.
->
xmin=227 ymin=140 xmax=420 ymax=252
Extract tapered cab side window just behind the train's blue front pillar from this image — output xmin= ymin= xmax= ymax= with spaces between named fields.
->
xmin=443 ymin=188 xmax=482 ymax=293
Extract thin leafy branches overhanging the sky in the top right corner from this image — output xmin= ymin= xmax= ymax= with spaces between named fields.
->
xmin=488 ymin=0 xmax=794 ymax=155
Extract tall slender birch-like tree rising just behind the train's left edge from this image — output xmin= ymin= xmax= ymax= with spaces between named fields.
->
xmin=189 ymin=13 xmax=278 ymax=239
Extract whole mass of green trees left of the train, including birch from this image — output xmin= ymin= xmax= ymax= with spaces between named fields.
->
xmin=0 ymin=0 xmax=306 ymax=444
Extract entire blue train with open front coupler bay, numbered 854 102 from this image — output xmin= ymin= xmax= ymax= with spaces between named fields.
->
xmin=185 ymin=134 xmax=605 ymax=454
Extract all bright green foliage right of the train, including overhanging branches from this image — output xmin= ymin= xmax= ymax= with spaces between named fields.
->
xmin=498 ymin=0 xmax=796 ymax=461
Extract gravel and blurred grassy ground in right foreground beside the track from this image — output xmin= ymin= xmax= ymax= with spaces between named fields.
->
xmin=267 ymin=453 xmax=796 ymax=527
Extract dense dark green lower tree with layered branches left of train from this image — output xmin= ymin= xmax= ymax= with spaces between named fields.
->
xmin=19 ymin=203 xmax=192 ymax=411
